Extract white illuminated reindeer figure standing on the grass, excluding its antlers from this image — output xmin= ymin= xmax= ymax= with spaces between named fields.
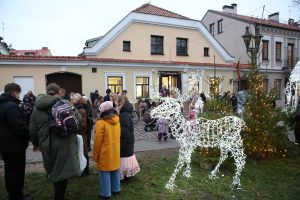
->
xmin=151 ymin=97 xmax=246 ymax=189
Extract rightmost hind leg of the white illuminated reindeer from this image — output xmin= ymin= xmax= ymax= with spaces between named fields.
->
xmin=231 ymin=144 xmax=246 ymax=189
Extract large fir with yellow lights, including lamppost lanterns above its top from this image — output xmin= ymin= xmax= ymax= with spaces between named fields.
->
xmin=243 ymin=25 xmax=287 ymax=159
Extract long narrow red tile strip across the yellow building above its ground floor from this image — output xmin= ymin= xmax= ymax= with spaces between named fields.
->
xmin=0 ymin=55 xmax=249 ymax=68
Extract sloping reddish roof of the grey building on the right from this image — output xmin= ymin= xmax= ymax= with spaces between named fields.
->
xmin=208 ymin=10 xmax=300 ymax=31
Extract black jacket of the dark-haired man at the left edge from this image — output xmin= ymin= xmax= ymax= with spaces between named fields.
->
xmin=0 ymin=94 xmax=29 ymax=153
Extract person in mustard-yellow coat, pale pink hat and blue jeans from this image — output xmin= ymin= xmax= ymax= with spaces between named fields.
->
xmin=93 ymin=101 xmax=121 ymax=199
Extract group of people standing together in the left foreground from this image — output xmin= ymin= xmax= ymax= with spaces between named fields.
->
xmin=0 ymin=83 xmax=140 ymax=200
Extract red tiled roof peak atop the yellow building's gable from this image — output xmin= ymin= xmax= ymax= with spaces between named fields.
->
xmin=132 ymin=3 xmax=190 ymax=19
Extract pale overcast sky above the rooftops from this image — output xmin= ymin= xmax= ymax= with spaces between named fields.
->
xmin=0 ymin=0 xmax=300 ymax=56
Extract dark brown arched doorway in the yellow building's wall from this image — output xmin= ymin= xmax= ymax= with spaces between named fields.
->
xmin=46 ymin=72 xmax=82 ymax=94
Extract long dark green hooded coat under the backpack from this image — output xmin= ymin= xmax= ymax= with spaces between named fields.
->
xmin=30 ymin=94 xmax=81 ymax=182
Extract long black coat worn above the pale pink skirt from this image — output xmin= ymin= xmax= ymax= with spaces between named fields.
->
xmin=120 ymin=101 xmax=134 ymax=157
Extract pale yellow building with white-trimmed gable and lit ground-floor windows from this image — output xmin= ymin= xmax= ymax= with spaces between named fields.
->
xmin=0 ymin=4 xmax=236 ymax=101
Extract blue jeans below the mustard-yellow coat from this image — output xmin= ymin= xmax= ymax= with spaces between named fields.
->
xmin=99 ymin=169 xmax=121 ymax=197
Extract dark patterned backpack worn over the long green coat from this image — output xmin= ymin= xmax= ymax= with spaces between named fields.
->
xmin=49 ymin=99 xmax=79 ymax=136
